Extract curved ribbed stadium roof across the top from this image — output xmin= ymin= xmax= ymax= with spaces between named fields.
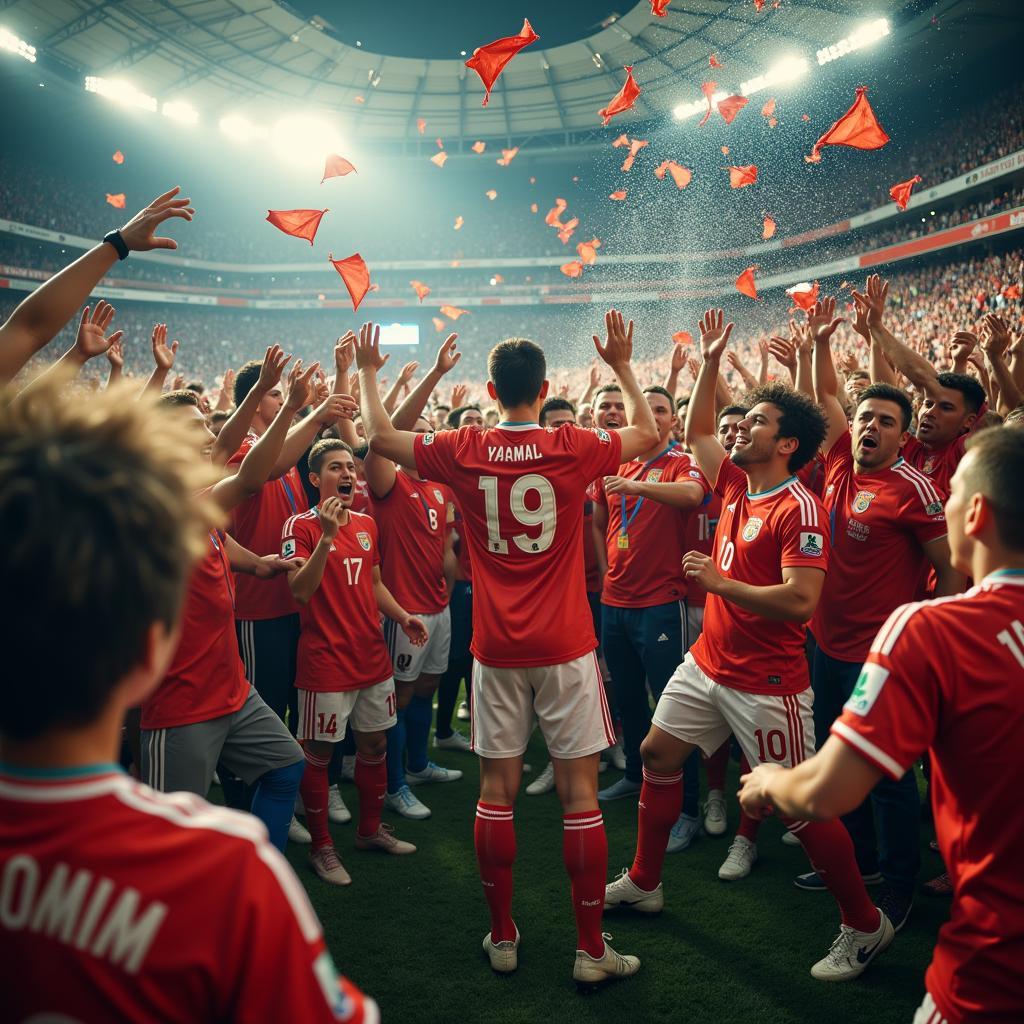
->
xmin=2 ymin=0 xmax=1019 ymax=145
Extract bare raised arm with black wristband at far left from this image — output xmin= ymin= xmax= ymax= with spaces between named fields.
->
xmin=0 ymin=187 xmax=196 ymax=384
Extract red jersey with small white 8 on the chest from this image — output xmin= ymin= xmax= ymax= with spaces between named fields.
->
xmin=373 ymin=470 xmax=449 ymax=615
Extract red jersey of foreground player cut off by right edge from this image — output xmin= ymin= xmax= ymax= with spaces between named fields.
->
xmin=831 ymin=569 xmax=1024 ymax=1024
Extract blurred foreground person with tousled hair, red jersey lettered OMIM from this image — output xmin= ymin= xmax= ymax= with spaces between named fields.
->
xmin=0 ymin=381 xmax=378 ymax=1024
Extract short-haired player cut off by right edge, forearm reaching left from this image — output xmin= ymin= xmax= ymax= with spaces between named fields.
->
xmin=740 ymin=429 xmax=1024 ymax=1024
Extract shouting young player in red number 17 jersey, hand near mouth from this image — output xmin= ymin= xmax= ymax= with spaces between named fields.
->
xmin=281 ymin=438 xmax=427 ymax=886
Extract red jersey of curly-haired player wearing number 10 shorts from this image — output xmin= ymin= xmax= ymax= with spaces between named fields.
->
xmin=690 ymin=459 xmax=828 ymax=696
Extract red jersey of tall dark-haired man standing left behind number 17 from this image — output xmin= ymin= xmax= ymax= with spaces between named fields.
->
xmin=227 ymin=434 xmax=309 ymax=621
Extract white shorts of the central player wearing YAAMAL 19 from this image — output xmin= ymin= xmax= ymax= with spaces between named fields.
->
xmin=471 ymin=651 xmax=615 ymax=759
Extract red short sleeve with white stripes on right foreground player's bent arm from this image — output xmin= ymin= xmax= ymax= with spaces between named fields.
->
xmin=831 ymin=605 xmax=941 ymax=779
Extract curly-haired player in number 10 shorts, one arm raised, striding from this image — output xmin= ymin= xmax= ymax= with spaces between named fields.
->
xmin=605 ymin=309 xmax=893 ymax=981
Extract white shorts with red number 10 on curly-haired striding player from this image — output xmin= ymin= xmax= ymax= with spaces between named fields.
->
xmin=653 ymin=654 xmax=814 ymax=768
